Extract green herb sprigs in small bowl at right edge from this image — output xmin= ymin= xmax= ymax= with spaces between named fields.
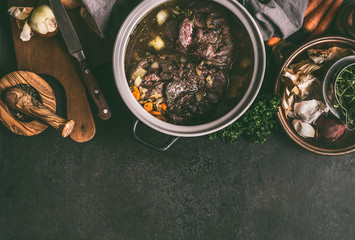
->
xmin=335 ymin=65 xmax=355 ymax=126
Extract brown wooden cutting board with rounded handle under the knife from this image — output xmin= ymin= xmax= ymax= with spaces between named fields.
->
xmin=8 ymin=0 xmax=96 ymax=142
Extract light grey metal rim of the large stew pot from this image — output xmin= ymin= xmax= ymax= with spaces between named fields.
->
xmin=113 ymin=0 xmax=266 ymax=137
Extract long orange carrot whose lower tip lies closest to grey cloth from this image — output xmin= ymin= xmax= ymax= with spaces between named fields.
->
xmin=303 ymin=0 xmax=334 ymax=33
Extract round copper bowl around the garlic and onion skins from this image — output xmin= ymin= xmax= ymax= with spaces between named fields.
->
xmin=274 ymin=36 xmax=355 ymax=156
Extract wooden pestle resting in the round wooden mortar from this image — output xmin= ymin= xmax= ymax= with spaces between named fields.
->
xmin=4 ymin=86 xmax=74 ymax=138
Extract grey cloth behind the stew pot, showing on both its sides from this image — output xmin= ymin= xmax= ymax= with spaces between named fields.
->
xmin=83 ymin=0 xmax=308 ymax=40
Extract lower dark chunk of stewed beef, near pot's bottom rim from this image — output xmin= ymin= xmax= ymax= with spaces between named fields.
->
xmin=165 ymin=63 xmax=227 ymax=123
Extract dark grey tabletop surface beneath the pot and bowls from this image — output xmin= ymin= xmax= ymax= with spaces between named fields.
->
xmin=0 ymin=1 xmax=355 ymax=240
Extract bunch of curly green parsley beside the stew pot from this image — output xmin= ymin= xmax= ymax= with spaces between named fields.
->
xmin=209 ymin=94 xmax=281 ymax=143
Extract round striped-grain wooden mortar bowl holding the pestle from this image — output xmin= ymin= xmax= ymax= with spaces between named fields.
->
xmin=0 ymin=71 xmax=56 ymax=136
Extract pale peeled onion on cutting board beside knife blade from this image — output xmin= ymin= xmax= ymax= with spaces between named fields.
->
xmin=30 ymin=5 xmax=58 ymax=37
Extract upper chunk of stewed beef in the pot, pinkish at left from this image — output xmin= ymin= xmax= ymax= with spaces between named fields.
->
xmin=177 ymin=5 xmax=233 ymax=68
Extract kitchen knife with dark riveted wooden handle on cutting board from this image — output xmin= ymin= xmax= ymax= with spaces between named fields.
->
xmin=49 ymin=0 xmax=111 ymax=120
